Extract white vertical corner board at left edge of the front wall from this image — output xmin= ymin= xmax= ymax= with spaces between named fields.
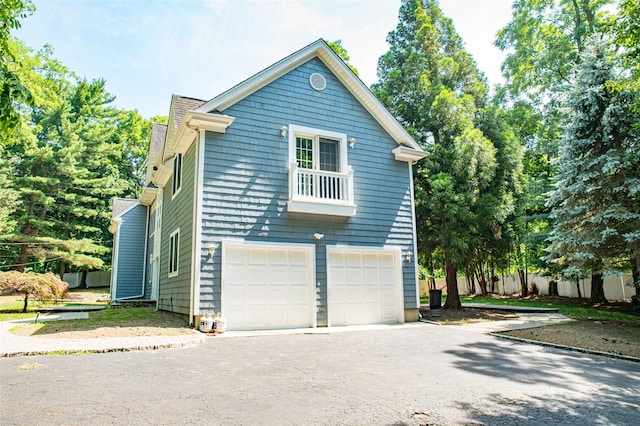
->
xmin=189 ymin=129 xmax=206 ymax=321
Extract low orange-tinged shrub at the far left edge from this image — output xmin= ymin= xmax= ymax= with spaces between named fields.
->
xmin=0 ymin=271 xmax=69 ymax=312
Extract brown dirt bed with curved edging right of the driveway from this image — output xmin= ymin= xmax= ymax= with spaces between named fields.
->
xmin=502 ymin=320 xmax=640 ymax=358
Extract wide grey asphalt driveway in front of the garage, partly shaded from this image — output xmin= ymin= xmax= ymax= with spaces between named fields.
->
xmin=0 ymin=323 xmax=640 ymax=425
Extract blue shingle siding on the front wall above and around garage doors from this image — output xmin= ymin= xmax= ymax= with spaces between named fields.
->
xmin=200 ymin=59 xmax=417 ymax=325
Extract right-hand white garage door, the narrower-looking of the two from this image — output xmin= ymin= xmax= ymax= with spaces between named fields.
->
xmin=327 ymin=247 xmax=404 ymax=325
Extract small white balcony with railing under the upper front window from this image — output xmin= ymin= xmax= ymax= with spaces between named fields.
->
xmin=287 ymin=163 xmax=356 ymax=216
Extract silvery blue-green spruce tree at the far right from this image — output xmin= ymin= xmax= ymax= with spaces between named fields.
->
xmin=549 ymin=36 xmax=640 ymax=303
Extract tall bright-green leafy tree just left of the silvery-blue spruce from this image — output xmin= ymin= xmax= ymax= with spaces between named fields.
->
xmin=495 ymin=0 xmax=615 ymax=294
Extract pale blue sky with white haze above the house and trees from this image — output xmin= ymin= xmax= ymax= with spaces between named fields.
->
xmin=14 ymin=0 xmax=513 ymax=118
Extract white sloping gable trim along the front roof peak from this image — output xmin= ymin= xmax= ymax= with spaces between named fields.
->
xmin=196 ymin=39 xmax=424 ymax=152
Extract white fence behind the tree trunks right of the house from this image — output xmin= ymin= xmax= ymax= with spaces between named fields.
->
xmin=420 ymin=274 xmax=636 ymax=300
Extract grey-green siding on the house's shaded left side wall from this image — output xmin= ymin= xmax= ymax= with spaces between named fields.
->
xmin=158 ymin=143 xmax=197 ymax=315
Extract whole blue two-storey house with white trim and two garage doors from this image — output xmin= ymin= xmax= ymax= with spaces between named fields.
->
xmin=111 ymin=40 xmax=426 ymax=330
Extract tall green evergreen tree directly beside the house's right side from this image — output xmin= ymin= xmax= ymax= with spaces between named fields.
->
xmin=373 ymin=0 xmax=496 ymax=309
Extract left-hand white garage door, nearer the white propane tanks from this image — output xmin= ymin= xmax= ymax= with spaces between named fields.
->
xmin=221 ymin=242 xmax=315 ymax=330
